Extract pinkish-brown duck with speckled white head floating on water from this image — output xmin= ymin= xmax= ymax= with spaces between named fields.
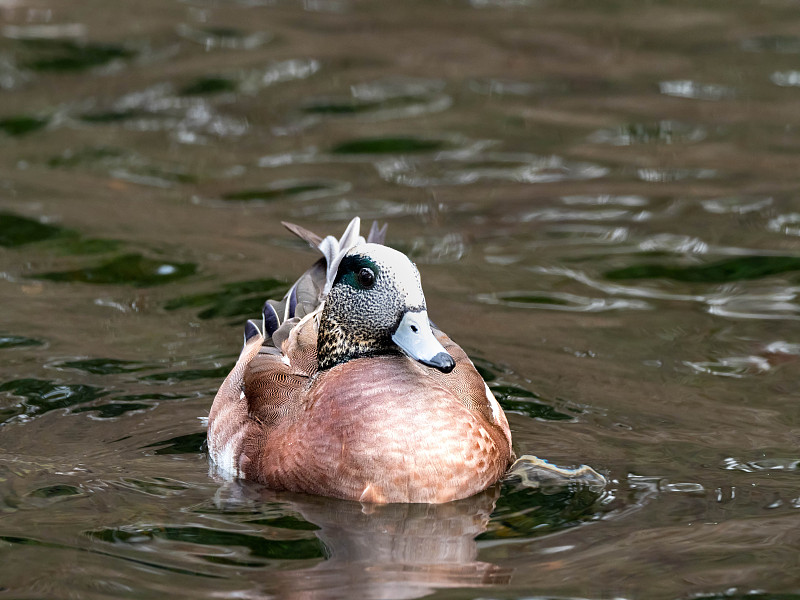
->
xmin=207 ymin=217 xmax=515 ymax=504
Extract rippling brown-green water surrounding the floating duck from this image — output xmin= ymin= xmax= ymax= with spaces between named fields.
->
xmin=0 ymin=0 xmax=800 ymax=599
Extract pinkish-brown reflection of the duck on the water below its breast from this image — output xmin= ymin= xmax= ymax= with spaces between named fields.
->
xmin=225 ymin=485 xmax=511 ymax=600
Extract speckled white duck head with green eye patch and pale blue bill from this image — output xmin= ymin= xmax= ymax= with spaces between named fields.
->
xmin=317 ymin=243 xmax=455 ymax=373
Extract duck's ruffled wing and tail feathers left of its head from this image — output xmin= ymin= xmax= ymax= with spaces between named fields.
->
xmin=208 ymin=217 xmax=386 ymax=476
